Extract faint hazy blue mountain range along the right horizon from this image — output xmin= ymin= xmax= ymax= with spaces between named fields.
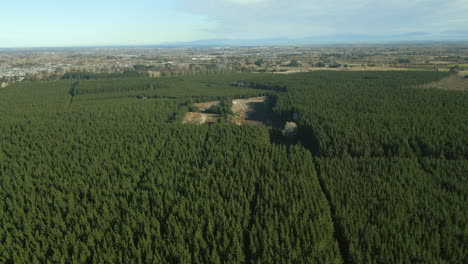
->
xmin=162 ymin=31 xmax=468 ymax=46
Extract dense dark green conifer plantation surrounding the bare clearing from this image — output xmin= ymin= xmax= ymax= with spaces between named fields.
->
xmin=0 ymin=71 xmax=468 ymax=263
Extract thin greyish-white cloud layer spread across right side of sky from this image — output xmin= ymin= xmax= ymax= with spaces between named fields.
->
xmin=179 ymin=0 xmax=468 ymax=38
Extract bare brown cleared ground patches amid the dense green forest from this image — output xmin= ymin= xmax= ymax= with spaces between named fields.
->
xmin=182 ymin=96 xmax=270 ymax=125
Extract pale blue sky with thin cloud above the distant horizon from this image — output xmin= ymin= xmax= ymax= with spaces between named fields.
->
xmin=0 ymin=0 xmax=468 ymax=47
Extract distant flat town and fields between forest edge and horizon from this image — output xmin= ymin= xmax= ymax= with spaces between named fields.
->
xmin=0 ymin=43 xmax=468 ymax=87
